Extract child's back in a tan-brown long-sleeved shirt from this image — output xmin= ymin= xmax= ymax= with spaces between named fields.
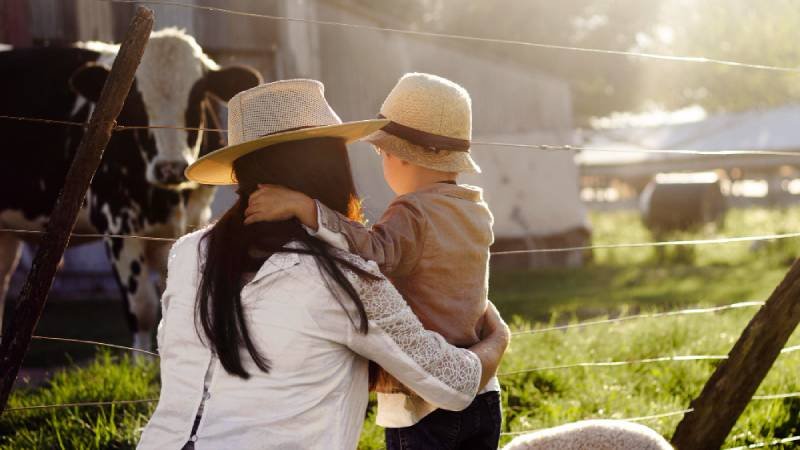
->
xmin=358 ymin=183 xmax=493 ymax=347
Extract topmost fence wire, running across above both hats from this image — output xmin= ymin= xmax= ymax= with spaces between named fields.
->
xmin=103 ymin=0 xmax=800 ymax=73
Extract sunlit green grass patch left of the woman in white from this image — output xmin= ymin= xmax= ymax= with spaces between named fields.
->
xmin=0 ymin=351 xmax=158 ymax=449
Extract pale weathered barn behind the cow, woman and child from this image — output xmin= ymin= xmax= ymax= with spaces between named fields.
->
xmin=0 ymin=0 xmax=590 ymax=308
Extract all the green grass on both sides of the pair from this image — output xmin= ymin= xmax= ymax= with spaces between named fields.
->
xmin=0 ymin=208 xmax=800 ymax=449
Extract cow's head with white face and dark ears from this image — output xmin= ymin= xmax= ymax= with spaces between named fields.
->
xmin=72 ymin=29 xmax=262 ymax=189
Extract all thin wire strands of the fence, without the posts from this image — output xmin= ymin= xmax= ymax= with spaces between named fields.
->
xmin=0 ymin=0 xmax=800 ymax=450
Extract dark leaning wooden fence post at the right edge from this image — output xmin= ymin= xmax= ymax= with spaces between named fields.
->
xmin=672 ymin=259 xmax=800 ymax=450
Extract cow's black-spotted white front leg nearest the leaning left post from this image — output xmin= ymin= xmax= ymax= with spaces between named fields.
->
xmin=106 ymin=238 xmax=158 ymax=356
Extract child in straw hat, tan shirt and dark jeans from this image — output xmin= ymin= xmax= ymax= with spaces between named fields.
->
xmin=245 ymin=73 xmax=500 ymax=450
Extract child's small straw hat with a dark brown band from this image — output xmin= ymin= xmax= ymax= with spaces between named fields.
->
xmin=364 ymin=73 xmax=481 ymax=173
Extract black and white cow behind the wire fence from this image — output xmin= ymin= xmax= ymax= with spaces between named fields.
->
xmin=0 ymin=29 xmax=261 ymax=348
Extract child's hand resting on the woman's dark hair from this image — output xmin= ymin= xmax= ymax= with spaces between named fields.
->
xmin=244 ymin=184 xmax=317 ymax=230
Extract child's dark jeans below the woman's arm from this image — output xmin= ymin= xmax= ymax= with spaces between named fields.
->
xmin=386 ymin=392 xmax=500 ymax=450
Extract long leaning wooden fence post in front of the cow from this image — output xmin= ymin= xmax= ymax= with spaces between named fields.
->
xmin=0 ymin=8 xmax=153 ymax=411
